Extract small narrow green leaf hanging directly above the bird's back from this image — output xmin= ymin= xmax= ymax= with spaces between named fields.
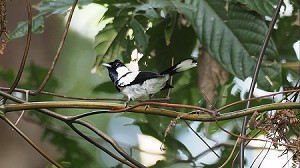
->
xmin=129 ymin=18 xmax=149 ymax=53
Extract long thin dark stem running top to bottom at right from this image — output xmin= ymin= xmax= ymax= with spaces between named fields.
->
xmin=239 ymin=0 xmax=283 ymax=168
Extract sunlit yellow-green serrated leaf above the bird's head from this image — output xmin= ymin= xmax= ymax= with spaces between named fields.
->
xmin=94 ymin=15 xmax=128 ymax=69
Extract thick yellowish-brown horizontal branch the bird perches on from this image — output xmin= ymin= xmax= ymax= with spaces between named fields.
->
xmin=0 ymin=101 xmax=300 ymax=121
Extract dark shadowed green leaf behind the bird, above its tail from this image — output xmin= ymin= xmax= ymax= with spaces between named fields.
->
xmin=139 ymin=22 xmax=196 ymax=72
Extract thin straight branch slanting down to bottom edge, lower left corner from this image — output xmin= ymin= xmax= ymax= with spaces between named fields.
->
xmin=0 ymin=115 xmax=62 ymax=168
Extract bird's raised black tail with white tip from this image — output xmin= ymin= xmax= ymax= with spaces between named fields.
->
xmin=160 ymin=58 xmax=197 ymax=75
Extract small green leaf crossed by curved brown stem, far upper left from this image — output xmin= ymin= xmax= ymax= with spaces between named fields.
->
xmin=9 ymin=15 xmax=44 ymax=40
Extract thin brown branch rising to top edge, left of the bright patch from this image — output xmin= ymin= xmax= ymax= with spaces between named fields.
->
xmin=33 ymin=0 xmax=78 ymax=94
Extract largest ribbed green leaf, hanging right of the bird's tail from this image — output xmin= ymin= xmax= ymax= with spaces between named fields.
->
xmin=192 ymin=0 xmax=281 ymax=90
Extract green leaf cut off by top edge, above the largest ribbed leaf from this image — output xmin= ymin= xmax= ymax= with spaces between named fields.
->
xmin=237 ymin=0 xmax=277 ymax=17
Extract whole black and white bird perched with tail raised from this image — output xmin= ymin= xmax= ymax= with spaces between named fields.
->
xmin=102 ymin=58 xmax=197 ymax=105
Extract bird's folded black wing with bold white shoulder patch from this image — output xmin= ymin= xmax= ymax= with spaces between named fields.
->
xmin=118 ymin=71 xmax=163 ymax=87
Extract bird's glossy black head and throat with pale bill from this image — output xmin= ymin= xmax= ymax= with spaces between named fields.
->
xmin=102 ymin=59 xmax=126 ymax=85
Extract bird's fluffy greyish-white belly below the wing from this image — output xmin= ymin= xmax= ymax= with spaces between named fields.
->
xmin=120 ymin=75 xmax=169 ymax=100
